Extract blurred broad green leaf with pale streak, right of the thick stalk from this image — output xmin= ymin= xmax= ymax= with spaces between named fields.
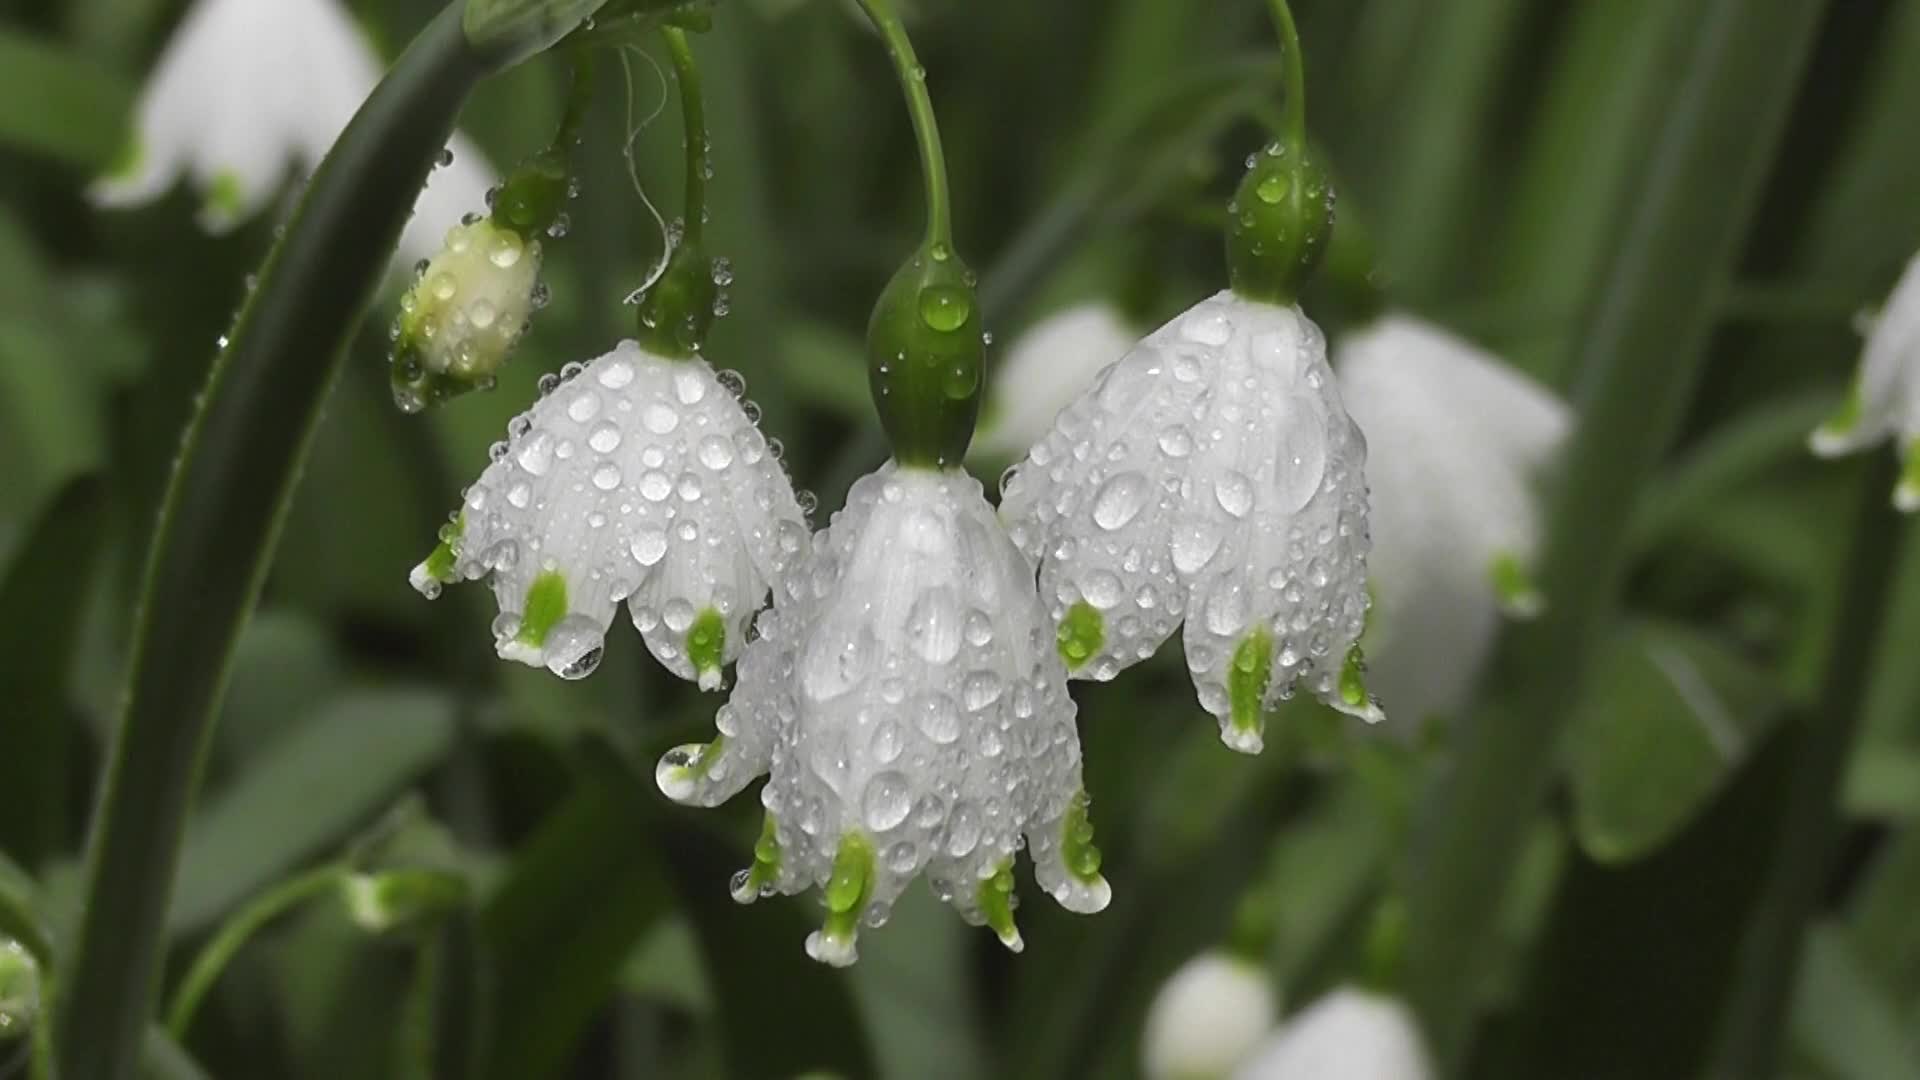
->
xmin=1569 ymin=623 xmax=1784 ymax=863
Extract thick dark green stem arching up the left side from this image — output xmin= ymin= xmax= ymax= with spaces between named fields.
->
xmin=56 ymin=4 xmax=495 ymax=1080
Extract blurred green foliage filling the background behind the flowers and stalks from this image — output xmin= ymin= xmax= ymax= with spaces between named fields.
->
xmin=0 ymin=0 xmax=1920 ymax=1080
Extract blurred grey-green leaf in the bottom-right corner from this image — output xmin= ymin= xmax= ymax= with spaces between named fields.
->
xmin=1788 ymin=922 xmax=1920 ymax=1080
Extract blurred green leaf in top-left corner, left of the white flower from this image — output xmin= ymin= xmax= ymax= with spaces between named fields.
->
xmin=0 ymin=29 xmax=132 ymax=171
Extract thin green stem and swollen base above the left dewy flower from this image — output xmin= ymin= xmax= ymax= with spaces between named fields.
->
xmin=639 ymin=27 xmax=720 ymax=359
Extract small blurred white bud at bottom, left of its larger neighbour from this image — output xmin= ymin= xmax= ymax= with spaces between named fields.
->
xmin=1140 ymin=951 xmax=1277 ymax=1080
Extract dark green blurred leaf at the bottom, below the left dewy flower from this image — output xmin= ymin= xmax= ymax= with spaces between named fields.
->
xmin=480 ymin=748 xmax=668 ymax=1080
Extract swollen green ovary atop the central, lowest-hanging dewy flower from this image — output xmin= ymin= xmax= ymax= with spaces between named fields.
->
xmin=866 ymin=244 xmax=987 ymax=469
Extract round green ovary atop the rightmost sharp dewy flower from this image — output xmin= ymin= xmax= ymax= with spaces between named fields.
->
xmin=1227 ymin=142 xmax=1332 ymax=304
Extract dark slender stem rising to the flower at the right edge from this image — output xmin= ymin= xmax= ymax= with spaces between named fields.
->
xmin=1711 ymin=454 xmax=1905 ymax=1076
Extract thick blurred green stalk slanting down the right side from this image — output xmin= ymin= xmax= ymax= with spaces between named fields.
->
xmin=1407 ymin=0 xmax=1826 ymax=1057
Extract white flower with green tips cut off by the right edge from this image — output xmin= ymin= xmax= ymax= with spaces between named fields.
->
xmin=1811 ymin=256 xmax=1920 ymax=513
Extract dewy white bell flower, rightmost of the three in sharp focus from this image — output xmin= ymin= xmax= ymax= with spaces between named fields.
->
xmin=1000 ymin=292 xmax=1382 ymax=753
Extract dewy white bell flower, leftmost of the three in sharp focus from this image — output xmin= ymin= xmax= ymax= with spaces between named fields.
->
xmin=413 ymin=342 xmax=806 ymax=690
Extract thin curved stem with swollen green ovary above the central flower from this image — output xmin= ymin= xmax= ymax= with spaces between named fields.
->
xmin=860 ymin=0 xmax=987 ymax=469
